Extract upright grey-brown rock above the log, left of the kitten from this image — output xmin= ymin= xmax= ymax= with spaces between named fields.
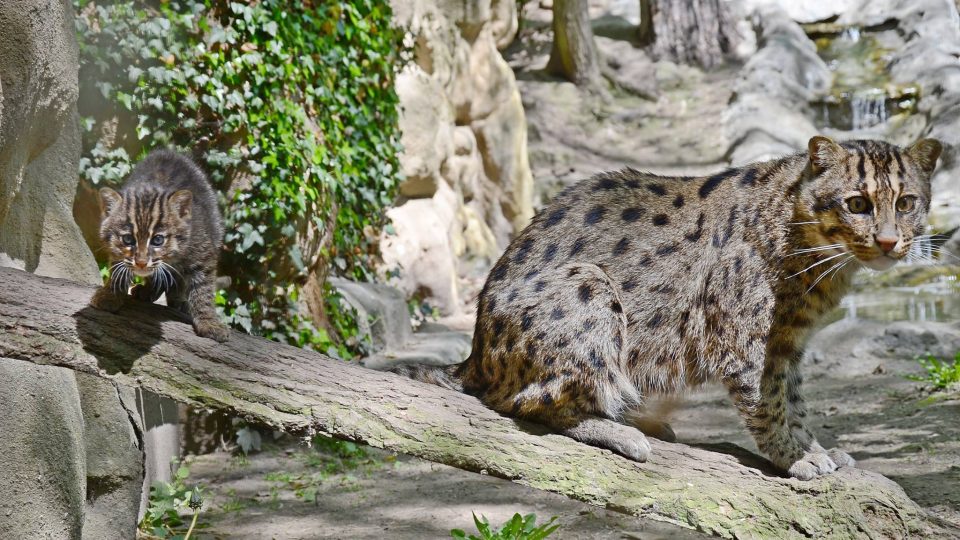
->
xmin=0 ymin=1 xmax=100 ymax=284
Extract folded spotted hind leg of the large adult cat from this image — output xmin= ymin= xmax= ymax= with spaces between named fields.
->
xmin=476 ymin=263 xmax=650 ymax=461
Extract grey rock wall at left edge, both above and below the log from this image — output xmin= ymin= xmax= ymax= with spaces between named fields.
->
xmin=0 ymin=0 xmax=143 ymax=539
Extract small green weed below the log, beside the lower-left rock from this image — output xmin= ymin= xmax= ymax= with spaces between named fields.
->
xmin=137 ymin=460 xmax=210 ymax=540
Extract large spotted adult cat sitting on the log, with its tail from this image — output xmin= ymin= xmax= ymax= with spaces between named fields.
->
xmin=399 ymin=137 xmax=941 ymax=479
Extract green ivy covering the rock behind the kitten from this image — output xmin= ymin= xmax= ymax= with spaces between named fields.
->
xmin=74 ymin=0 xmax=406 ymax=357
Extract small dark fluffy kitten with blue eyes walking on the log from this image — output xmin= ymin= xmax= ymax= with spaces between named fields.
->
xmin=90 ymin=150 xmax=229 ymax=342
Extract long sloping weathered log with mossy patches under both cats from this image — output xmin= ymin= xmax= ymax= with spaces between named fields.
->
xmin=0 ymin=268 xmax=958 ymax=538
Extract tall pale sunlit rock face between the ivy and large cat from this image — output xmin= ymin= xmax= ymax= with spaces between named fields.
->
xmin=381 ymin=0 xmax=533 ymax=315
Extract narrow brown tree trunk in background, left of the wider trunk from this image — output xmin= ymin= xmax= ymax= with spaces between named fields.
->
xmin=547 ymin=0 xmax=600 ymax=86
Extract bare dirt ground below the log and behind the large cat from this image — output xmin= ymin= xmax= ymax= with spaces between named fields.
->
xmin=189 ymin=3 xmax=960 ymax=539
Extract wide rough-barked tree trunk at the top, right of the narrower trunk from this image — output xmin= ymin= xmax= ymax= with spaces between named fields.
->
xmin=638 ymin=0 xmax=740 ymax=68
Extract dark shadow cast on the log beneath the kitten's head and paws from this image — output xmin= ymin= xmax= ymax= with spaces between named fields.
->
xmin=73 ymin=300 xmax=185 ymax=375
